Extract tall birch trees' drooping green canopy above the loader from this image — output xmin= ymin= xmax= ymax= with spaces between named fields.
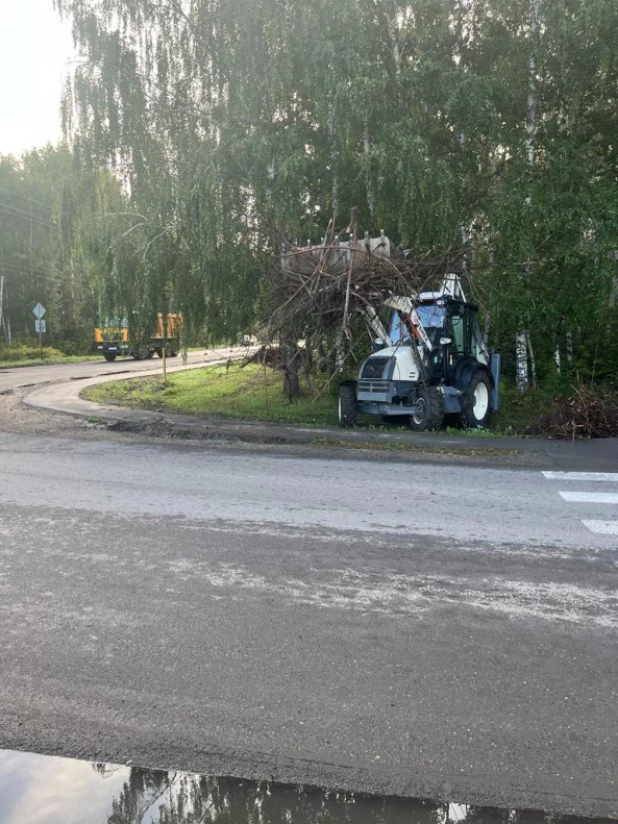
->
xmin=44 ymin=0 xmax=618 ymax=380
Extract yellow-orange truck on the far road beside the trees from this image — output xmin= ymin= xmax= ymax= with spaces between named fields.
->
xmin=94 ymin=312 xmax=182 ymax=362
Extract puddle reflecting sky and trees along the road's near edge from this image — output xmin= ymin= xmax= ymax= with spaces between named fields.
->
xmin=0 ymin=750 xmax=601 ymax=824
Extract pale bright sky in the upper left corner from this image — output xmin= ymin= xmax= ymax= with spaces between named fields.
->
xmin=0 ymin=0 xmax=75 ymax=155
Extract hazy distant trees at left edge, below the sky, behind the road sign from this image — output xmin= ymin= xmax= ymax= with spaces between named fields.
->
xmin=0 ymin=146 xmax=123 ymax=354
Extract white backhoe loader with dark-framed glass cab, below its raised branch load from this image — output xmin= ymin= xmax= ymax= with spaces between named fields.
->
xmin=339 ymin=275 xmax=500 ymax=431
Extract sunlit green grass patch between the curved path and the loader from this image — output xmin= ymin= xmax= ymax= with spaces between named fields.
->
xmin=82 ymin=364 xmax=337 ymax=425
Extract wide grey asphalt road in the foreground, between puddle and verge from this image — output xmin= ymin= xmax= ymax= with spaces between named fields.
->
xmin=0 ymin=432 xmax=618 ymax=817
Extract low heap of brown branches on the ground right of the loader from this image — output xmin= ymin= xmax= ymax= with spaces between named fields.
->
xmin=533 ymin=382 xmax=618 ymax=440
